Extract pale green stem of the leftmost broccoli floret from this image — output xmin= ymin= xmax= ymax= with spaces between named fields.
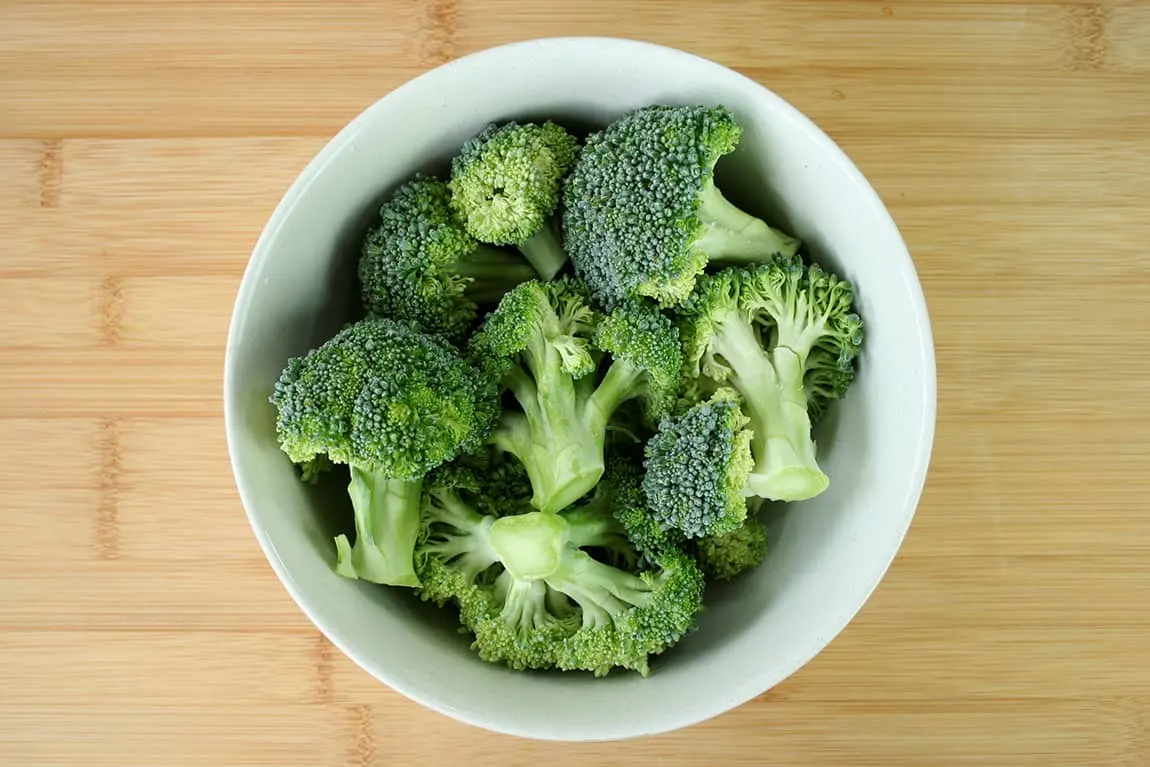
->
xmin=336 ymin=466 xmax=423 ymax=588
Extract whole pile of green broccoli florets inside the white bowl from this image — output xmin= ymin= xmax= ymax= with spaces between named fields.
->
xmin=264 ymin=105 xmax=863 ymax=676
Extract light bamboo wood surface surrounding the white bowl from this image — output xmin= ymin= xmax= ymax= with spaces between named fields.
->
xmin=0 ymin=0 xmax=1150 ymax=767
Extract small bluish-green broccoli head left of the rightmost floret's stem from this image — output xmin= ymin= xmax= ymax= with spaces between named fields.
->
xmin=643 ymin=389 xmax=754 ymax=538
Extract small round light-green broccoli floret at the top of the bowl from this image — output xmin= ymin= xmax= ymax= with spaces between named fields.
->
xmin=451 ymin=122 xmax=578 ymax=279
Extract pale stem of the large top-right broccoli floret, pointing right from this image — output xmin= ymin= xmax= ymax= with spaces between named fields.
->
xmin=695 ymin=178 xmax=800 ymax=263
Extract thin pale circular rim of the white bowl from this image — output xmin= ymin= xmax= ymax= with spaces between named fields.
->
xmin=223 ymin=36 xmax=937 ymax=742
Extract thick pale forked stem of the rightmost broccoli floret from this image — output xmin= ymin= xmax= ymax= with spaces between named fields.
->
xmin=715 ymin=317 xmax=830 ymax=501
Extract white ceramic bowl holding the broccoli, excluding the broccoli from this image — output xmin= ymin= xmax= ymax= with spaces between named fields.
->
xmin=224 ymin=38 xmax=935 ymax=739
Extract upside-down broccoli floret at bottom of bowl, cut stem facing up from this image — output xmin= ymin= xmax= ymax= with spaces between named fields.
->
xmin=416 ymin=469 xmax=704 ymax=676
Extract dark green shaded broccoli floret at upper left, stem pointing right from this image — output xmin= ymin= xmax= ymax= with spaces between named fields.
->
xmin=359 ymin=176 xmax=536 ymax=340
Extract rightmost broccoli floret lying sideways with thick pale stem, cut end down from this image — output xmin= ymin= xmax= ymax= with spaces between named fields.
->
xmin=680 ymin=256 xmax=863 ymax=500
